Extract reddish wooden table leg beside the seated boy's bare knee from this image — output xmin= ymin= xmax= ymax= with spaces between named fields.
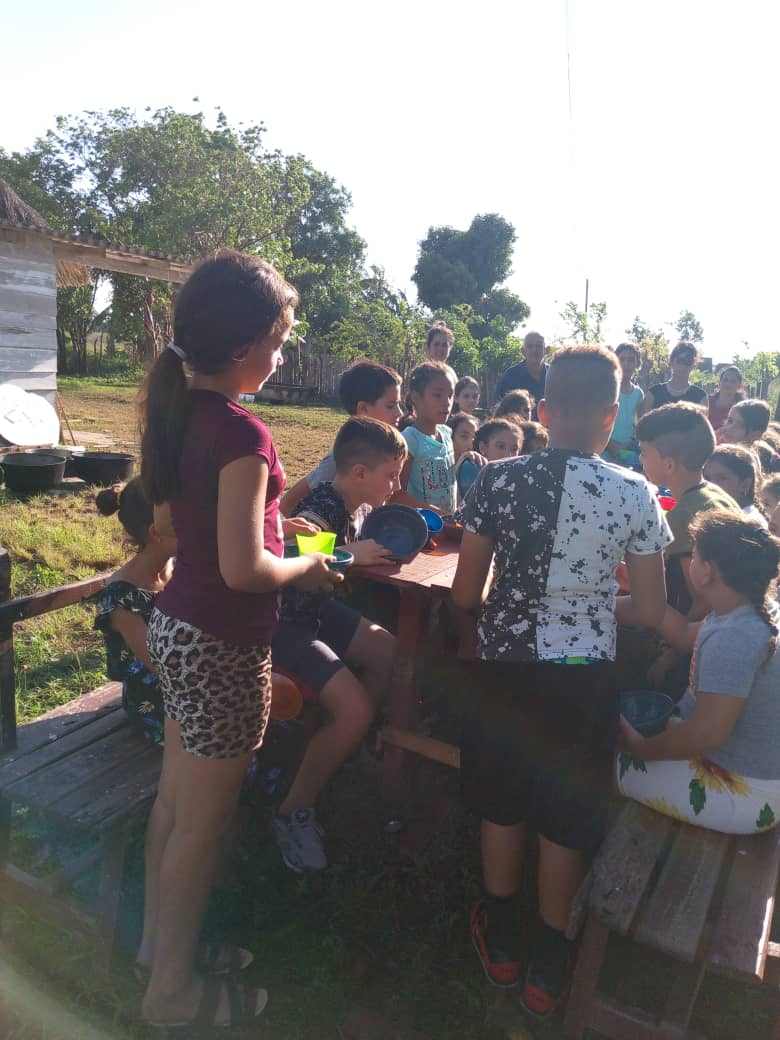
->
xmin=382 ymin=589 xmax=428 ymax=808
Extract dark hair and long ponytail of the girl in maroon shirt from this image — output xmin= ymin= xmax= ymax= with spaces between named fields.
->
xmin=140 ymin=250 xmax=297 ymax=505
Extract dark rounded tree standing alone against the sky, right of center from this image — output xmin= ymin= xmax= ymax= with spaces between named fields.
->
xmin=412 ymin=213 xmax=530 ymax=328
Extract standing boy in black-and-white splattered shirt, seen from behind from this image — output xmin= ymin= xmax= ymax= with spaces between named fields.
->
xmin=452 ymin=347 xmax=672 ymax=1016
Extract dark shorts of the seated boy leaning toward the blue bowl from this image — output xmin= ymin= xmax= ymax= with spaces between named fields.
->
xmin=271 ymin=599 xmax=362 ymax=700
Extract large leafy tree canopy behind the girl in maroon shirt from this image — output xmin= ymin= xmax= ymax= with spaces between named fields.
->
xmin=0 ymin=107 xmax=364 ymax=364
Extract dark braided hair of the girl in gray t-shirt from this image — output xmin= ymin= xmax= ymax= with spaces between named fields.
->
xmin=691 ymin=510 xmax=780 ymax=660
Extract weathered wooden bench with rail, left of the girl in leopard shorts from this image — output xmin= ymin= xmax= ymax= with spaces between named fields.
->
xmin=0 ymin=550 xmax=162 ymax=970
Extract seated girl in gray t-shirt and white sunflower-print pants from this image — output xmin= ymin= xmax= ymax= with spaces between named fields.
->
xmin=616 ymin=510 xmax=780 ymax=834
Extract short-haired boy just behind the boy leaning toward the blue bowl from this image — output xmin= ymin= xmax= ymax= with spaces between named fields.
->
xmin=280 ymin=361 xmax=404 ymax=517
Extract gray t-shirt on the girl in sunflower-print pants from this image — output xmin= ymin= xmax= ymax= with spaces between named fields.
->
xmin=680 ymin=605 xmax=780 ymax=780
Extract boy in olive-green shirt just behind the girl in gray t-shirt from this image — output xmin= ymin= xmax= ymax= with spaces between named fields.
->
xmin=636 ymin=401 xmax=739 ymax=615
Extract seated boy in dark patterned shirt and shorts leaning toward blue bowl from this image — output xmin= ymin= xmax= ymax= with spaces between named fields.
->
xmin=271 ymin=419 xmax=407 ymax=873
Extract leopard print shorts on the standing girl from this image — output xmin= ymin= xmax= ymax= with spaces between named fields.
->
xmin=147 ymin=608 xmax=270 ymax=758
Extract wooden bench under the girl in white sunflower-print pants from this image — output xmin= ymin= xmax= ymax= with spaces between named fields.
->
xmin=565 ymin=802 xmax=780 ymax=1040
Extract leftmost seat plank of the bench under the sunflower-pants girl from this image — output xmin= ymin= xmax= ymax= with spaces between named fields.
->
xmin=591 ymin=802 xmax=672 ymax=935
